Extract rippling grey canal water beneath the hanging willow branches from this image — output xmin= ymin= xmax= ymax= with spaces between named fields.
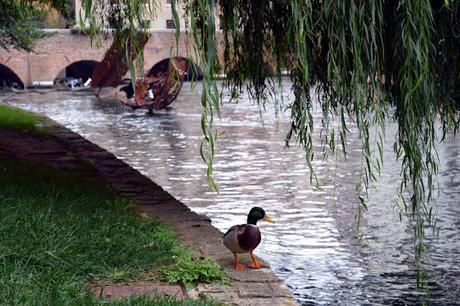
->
xmin=0 ymin=83 xmax=460 ymax=305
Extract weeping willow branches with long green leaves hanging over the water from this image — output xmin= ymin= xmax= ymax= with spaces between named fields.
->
xmin=76 ymin=0 xmax=460 ymax=292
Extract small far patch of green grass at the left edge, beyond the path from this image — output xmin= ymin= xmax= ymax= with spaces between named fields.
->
xmin=0 ymin=105 xmax=47 ymax=134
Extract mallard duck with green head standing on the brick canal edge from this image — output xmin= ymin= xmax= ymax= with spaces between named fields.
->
xmin=224 ymin=207 xmax=275 ymax=270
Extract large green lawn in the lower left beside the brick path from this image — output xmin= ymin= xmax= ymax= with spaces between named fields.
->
xmin=0 ymin=155 xmax=226 ymax=305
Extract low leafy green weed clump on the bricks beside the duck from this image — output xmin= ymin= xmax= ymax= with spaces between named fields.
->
xmin=162 ymin=249 xmax=230 ymax=287
